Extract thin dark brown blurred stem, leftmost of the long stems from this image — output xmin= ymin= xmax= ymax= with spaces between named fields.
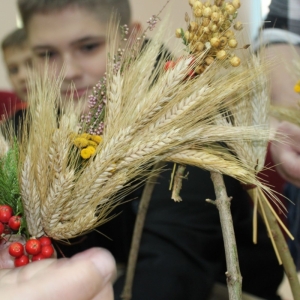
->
xmin=121 ymin=163 xmax=162 ymax=300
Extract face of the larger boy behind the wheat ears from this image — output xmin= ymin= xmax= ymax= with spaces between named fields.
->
xmin=27 ymin=7 xmax=106 ymax=109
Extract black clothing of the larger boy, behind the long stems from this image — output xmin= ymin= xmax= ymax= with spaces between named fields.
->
xmin=56 ymin=164 xmax=283 ymax=300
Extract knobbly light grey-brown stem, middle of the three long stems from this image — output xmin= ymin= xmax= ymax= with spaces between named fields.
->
xmin=210 ymin=172 xmax=242 ymax=300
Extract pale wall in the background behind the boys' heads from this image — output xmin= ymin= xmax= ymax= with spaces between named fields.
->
xmin=0 ymin=0 xmax=266 ymax=89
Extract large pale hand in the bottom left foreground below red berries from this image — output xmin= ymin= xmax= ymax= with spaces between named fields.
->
xmin=0 ymin=248 xmax=116 ymax=300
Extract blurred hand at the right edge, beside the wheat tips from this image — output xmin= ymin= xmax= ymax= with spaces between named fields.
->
xmin=271 ymin=122 xmax=300 ymax=187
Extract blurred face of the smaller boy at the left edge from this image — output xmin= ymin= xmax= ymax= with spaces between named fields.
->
xmin=3 ymin=44 xmax=32 ymax=101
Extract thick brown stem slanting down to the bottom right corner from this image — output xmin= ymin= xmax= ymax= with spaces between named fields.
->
xmin=259 ymin=190 xmax=300 ymax=299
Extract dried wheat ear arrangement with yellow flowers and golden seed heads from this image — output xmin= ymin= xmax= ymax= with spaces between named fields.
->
xmin=0 ymin=0 xmax=296 ymax=299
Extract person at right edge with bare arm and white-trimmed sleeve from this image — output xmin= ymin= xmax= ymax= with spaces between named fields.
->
xmin=255 ymin=0 xmax=300 ymax=270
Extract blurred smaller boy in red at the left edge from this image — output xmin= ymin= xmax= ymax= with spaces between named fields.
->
xmin=0 ymin=29 xmax=32 ymax=118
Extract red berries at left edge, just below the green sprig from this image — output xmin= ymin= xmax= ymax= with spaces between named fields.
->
xmin=0 ymin=205 xmax=22 ymax=235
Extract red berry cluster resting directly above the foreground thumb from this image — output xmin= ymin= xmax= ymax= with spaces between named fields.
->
xmin=8 ymin=236 xmax=54 ymax=267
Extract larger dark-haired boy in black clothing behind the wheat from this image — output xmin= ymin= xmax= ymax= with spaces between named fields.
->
xmin=10 ymin=0 xmax=283 ymax=300
